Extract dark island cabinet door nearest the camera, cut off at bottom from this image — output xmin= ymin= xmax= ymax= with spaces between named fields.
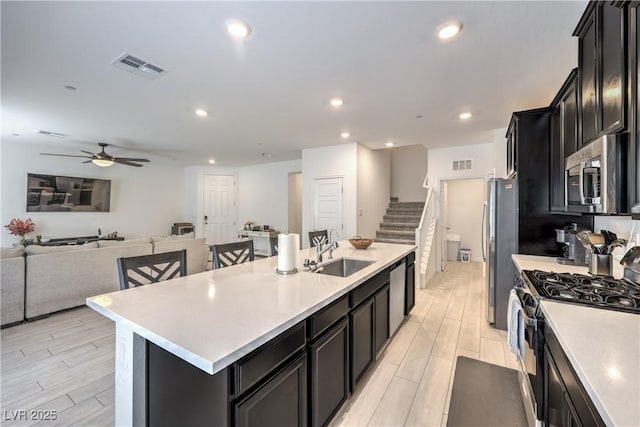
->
xmin=233 ymin=354 xmax=307 ymax=427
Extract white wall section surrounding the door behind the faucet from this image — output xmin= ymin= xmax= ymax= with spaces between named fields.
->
xmin=301 ymin=143 xmax=358 ymax=248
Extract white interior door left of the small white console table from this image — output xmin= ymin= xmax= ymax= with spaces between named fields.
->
xmin=203 ymin=175 xmax=238 ymax=245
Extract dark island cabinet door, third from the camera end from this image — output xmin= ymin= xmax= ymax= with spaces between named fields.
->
xmin=349 ymin=297 xmax=375 ymax=390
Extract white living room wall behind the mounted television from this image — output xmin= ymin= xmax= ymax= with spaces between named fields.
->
xmin=0 ymin=140 xmax=185 ymax=246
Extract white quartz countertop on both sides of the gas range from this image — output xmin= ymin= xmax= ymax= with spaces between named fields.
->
xmin=512 ymin=255 xmax=640 ymax=426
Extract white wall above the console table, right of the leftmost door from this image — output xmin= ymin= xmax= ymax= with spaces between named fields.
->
xmin=236 ymin=160 xmax=302 ymax=232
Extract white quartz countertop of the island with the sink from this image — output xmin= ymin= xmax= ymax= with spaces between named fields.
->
xmin=87 ymin=240 xmax=416 ymax=374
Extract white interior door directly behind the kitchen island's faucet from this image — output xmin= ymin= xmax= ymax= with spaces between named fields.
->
xmin=307 ymin=178 xmax=344 ymax=241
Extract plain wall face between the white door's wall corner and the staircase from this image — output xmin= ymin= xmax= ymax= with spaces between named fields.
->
xmin=356 ymin=145 xmax=390 ymax=238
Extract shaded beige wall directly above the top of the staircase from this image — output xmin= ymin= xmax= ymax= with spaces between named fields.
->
xmin=388 ymin=145 xmax=427 ymax=202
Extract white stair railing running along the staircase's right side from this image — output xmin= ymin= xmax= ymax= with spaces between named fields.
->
xmin=416 ymin=176 xmax=438 ymax=289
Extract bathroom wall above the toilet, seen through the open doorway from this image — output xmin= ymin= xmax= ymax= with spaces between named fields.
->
xmin=447 ymin=179 xmax=485 ymax=261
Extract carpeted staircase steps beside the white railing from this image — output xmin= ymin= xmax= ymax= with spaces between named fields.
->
xmin=376 ymin=197 xmax=424 ymax=245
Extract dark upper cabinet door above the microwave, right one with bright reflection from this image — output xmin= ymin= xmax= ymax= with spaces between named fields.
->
xmin=597 ymin=2 xmax=626 ymax=135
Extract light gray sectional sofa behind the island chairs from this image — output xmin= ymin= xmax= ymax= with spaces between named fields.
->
xmin=0 ymin=236 xmax=209 ymax=326
